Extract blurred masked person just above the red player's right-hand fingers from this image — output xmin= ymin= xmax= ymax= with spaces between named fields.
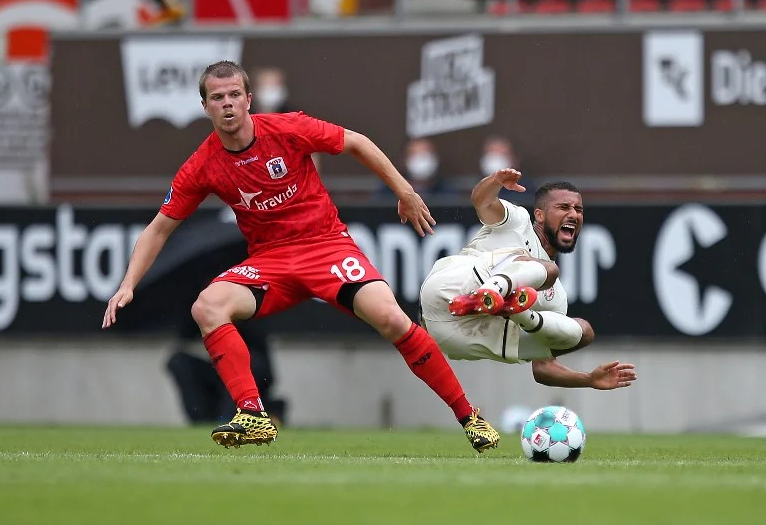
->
xmin=379 ymin=138 xmax=453 ymax=202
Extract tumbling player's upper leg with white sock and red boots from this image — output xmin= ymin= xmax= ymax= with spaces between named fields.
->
xmin=449 ymin=255 xmax=559 ymax=316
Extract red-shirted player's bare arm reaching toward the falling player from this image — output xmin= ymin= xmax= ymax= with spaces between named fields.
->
xmin=343 ymin=129 xmax=436 ymax=237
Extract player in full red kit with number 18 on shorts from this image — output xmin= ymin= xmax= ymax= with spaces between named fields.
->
xmin=102 ymin=61 xmax=499 ymax=452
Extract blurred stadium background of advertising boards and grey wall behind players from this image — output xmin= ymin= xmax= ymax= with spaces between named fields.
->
xmin=0 ymin=0 xmax=766 ymax=435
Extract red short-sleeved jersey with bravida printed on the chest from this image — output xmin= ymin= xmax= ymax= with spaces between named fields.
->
xmin=166 ymin=112 xmax=347 ymax=255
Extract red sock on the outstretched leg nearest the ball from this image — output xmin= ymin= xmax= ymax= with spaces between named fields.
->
xmin=394 ymin=323 xmax=472 ymax=421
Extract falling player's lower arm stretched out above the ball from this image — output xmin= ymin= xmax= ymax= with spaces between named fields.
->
xmin=532 ymin=358 xmax=637 ymax=390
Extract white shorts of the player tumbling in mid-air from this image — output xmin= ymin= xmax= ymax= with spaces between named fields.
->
xmin=420 ymin=250 xmax=551 ymax=363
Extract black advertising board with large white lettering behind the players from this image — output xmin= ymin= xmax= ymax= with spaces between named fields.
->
xmin=0 ymin=204 xmax=766 ymax=338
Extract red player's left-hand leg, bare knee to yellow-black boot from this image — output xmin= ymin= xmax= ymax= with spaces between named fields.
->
xmin=192 ymin=281 xmax=277 ymax=448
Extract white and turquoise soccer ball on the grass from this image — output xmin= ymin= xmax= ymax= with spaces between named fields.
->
xmin=521 ymin=406 xmax=585 ymax=463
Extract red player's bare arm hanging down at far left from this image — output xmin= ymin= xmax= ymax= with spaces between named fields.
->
xmin=101 ymin=213 xmax=181 ymax=328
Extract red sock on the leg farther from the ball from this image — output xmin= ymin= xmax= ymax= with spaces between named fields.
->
xmin=202 ymin=323 xmax=264 ymax=411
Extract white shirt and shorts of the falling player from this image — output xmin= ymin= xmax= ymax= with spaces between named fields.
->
xmin=420 ymin=199 xmax=568 ymax=363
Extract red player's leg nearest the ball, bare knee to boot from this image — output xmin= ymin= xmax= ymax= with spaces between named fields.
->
xmin=353 ymin=281 xmax=500 ymax=452
